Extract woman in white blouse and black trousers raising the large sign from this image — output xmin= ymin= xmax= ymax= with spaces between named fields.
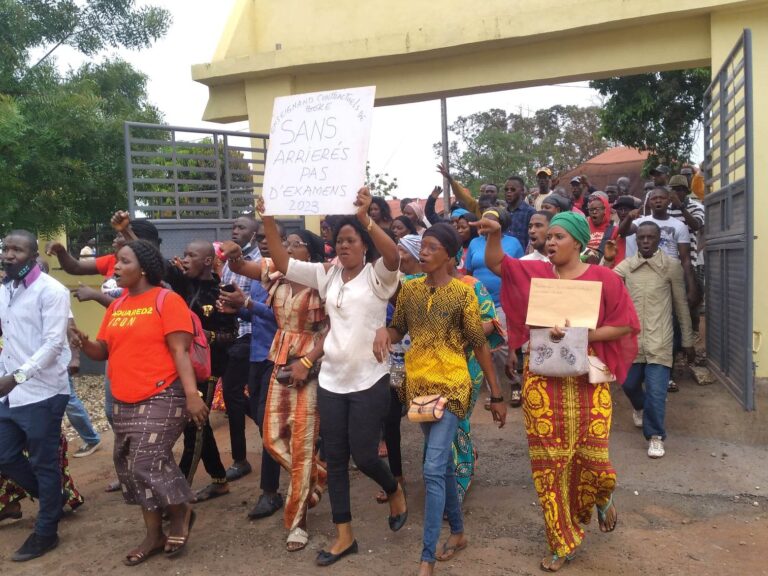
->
xmin=224 ymin=188 xmax=408 ymax=566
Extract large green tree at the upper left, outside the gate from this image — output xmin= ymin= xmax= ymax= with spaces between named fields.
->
xmin=0 ymin=0 xmax=170 ymax=233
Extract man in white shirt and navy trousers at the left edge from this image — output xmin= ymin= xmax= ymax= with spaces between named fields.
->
xmin=0 ymin=230 xmax=70 ymax=562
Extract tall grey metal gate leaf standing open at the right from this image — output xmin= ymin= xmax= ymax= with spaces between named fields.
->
xmin=703 ymin=29 xmax=755 ymax=410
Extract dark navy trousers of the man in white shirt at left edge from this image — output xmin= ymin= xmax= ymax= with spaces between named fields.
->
xmin=0 ymin=394 xmax=69 ymax=537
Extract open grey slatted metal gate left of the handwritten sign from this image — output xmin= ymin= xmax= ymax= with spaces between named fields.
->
xmin=124 ymin=122 xmax=303 ymax=257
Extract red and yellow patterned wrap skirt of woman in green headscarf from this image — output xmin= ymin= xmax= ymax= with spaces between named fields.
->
xmin=523 ymin=355 xmax=616 ymax=556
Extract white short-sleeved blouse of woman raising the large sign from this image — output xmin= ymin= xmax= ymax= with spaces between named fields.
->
xmin=285 ymin=258 xmax=398 ymax=394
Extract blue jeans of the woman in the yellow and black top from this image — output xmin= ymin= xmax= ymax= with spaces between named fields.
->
xmin=421 ymin=410 xmax=464 ymax=562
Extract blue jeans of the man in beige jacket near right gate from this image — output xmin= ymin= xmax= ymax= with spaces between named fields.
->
xmin=622 ymin=364 xmax=670 ymax=440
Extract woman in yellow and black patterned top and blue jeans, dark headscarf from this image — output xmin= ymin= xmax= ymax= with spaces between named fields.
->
xmin=374 ymin=223 xmax=506 ymax=576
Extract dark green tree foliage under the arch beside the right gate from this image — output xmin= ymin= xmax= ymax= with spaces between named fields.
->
xmin=589 ymin=68 xmax=710 ymax=164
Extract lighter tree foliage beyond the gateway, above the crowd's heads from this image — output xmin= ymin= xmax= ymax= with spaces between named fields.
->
xmin=434 ymin=106 xmax=608 ymax=190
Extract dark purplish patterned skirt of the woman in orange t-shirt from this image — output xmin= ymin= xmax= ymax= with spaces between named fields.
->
xmin=113 ymin=380 xmax=194 ymax=510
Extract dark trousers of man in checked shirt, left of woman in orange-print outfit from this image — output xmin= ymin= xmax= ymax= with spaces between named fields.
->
xmin=221 ymin=334 xmax=251 ymax=462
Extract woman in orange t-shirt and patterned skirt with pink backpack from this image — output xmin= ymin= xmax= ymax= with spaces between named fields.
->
xmin=79 ymin=240 xmax=208 ymax=566
